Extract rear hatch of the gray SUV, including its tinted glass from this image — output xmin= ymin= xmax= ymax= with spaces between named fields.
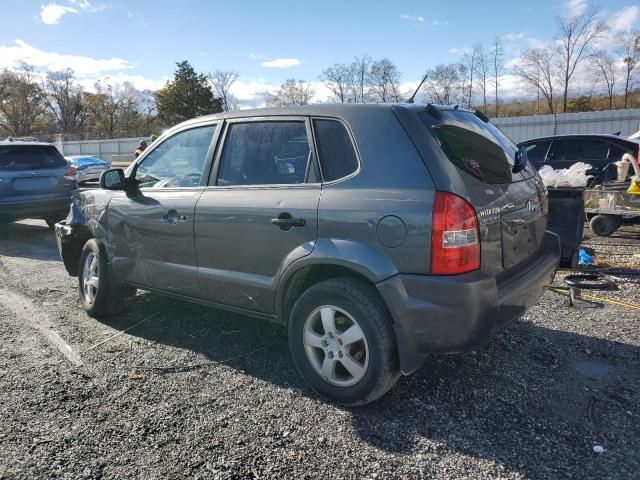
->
xmin=399 ymin=106 xmax=547 ymax=275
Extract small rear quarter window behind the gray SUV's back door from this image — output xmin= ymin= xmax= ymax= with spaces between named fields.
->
xmin=313 ymin=119 xmax=358 ymax=182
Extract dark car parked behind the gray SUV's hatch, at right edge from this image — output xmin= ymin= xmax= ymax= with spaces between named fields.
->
xmin=518 ymin=134 xmax=640 ymax=181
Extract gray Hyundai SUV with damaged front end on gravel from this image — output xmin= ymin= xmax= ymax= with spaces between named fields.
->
xmin=56 ymin=104 xmax=560 ymax=405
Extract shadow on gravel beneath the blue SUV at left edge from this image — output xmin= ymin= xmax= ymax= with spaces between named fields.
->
xmin=0 ymin=220 xmax=60 ymax=261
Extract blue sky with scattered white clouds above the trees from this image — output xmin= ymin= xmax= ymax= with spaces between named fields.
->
xmin=0 ymin=0 xmax=640 ymax=107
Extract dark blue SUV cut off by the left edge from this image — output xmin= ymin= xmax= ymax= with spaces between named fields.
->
xmin=0 ymin=139 xmax=76 ymax=228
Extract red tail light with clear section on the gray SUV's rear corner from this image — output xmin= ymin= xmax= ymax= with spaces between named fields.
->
xmin=431 ymin=192 xmax=480 ymax=275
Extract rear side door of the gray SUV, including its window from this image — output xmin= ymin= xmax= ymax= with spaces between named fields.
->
xmin=195 ymin=117 xmax=320 ymax=313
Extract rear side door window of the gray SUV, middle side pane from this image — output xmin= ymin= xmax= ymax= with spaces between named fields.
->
xmin=217 ymin=120 xmax=311 ymax=186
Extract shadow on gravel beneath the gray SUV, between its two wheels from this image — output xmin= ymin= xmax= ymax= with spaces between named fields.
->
xmin=97 ymin=293 xmax=302 ymax=384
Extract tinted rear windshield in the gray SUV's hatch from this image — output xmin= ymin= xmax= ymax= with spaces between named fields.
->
xmin=419 ymin=110 xmax=535 ymax=183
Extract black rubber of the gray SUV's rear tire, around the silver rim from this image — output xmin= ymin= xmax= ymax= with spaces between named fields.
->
xmin=289 ymin=278 xmax=400 ymax=406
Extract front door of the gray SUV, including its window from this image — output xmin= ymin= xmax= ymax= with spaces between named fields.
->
xmin=107 ymin=124 xmax=216 ymax=296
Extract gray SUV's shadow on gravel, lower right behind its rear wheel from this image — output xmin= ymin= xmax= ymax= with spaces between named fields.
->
xmin=352 ymin=321 xmax=640 ymax=478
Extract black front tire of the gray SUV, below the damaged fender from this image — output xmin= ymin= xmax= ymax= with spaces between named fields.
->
xmin=78 ymin=238 xmax=129 ymax=318
